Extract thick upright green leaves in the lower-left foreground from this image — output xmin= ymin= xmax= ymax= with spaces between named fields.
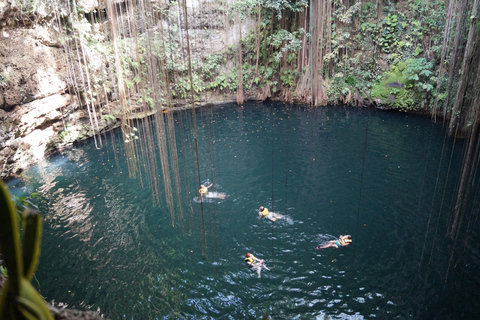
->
xmin=0 ymin=181 xmax=53 ymax=320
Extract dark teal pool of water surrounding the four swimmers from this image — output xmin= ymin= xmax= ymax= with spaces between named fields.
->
xmin=9 ymin=103 xmax=480 ymax=319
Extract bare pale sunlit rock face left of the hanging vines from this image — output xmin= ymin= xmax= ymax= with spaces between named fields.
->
xmin=0 ymin=0 xmax=116 ymax=180
